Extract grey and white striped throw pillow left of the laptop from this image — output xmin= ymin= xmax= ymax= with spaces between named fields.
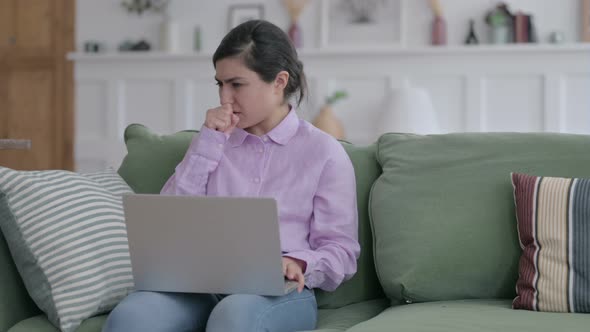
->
xmin=0 ymin=167 xmax=133 ymax=332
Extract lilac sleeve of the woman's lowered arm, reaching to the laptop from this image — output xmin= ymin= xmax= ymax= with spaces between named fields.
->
xmin=285 ymin=146 xmax=360 ymax=291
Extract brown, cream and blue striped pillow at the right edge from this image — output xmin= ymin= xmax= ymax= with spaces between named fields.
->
xmin=512 ymin=173 xmax=590 ymax=312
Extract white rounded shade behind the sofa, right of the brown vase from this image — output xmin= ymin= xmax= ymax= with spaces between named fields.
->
xmin=379 ymin=83 xmax=440 ymax=135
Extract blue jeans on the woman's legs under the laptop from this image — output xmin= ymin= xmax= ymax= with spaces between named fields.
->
xmin=103 ymin=288 xmax=317 ymax=332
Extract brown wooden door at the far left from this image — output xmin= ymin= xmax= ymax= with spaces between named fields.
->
xmin=0 ymin=0 xmax=74 ymax=170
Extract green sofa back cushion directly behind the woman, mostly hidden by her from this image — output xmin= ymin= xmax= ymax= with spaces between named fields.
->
xmin=119 ymin=124 xmax=384 ymax=308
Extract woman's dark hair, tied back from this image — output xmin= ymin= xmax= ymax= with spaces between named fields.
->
xmin=213 ymin=20 xmax=307 ymax=105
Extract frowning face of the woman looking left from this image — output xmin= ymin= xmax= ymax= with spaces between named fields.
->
xmin=215 ymin=57 xmax=284 ymax=129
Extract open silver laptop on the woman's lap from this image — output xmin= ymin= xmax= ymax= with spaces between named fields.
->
xmin=123 ymin=194 xmax=297 ymax=296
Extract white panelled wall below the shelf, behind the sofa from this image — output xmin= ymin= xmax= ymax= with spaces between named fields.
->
xmin=70 ymin=45 xmax=590 ymax=171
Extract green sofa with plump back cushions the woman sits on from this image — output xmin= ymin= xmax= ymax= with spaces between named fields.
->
xmin=0 ymin=125 xmax=590 ymax=332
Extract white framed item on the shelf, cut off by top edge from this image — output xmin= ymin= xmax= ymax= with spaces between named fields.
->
xmin=320 ymin=0 xmax=406 ymax=48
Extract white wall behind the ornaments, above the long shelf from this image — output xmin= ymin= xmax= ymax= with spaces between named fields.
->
xmin=76 ymin=0 xmax=581 ymax=52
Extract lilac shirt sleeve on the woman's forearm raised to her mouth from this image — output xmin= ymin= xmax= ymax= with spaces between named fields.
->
xmin=160 ymin=126 xmax=227 ymax=196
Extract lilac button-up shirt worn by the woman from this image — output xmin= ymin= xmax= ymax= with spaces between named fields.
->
xmin=162 ymin=111 xmax=360 ymax=291
